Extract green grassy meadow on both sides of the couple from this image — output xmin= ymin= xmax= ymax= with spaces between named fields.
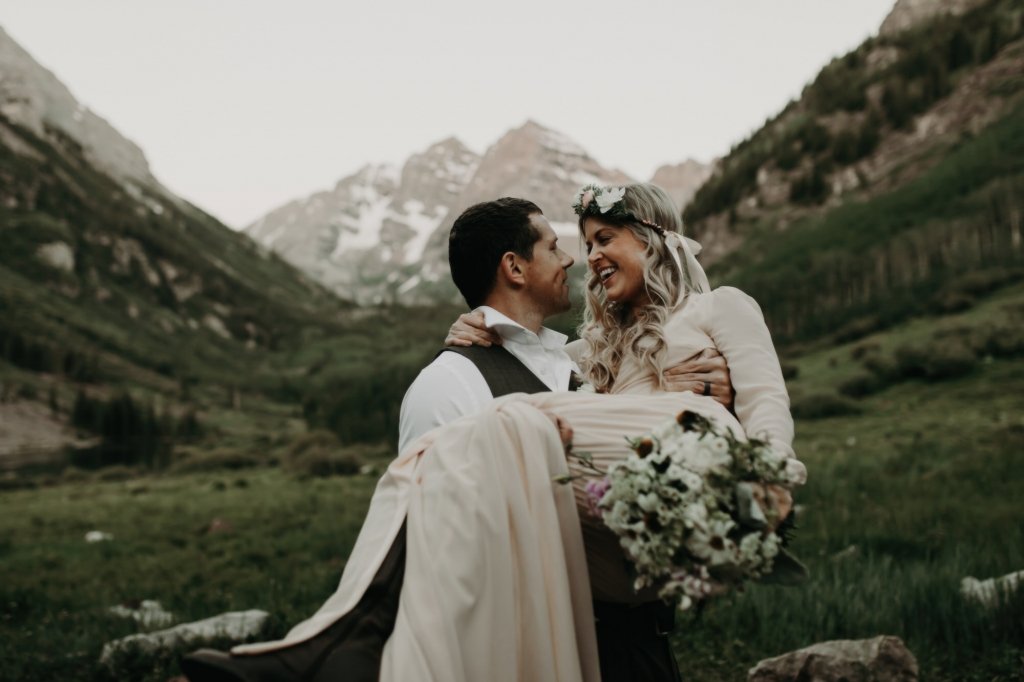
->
xmin=0 ymin=286 xmax=1024 ymax=681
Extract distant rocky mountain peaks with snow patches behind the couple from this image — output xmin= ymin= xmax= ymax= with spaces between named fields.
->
xmin=246 ymin=121 xmax=710 ymax=303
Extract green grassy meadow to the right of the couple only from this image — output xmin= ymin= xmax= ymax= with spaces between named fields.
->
xmin=676 ymin=287 xmax=1024 ymax=681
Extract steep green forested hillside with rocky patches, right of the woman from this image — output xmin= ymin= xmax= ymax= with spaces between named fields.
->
xmin=684 ymin=0 xmax=1024 ymax=343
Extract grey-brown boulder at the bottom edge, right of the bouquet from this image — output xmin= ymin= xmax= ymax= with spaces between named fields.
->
xmin=746 ymin=635 xmax=918 ymax=682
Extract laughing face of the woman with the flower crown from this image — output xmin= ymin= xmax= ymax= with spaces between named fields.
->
xmin=583 ymin=218 xmax=647 ymax=305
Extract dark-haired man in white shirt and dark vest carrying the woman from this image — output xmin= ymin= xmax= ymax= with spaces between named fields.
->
xmin=181 ymin=198 xmax=731 ymax=682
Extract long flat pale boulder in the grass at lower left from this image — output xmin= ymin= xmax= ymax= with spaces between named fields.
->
xmin=99 ymin=609 xmax=270 ymax=664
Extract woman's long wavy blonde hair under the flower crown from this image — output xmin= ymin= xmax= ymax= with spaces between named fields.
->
xmin=579 ymin=183 xmax=691 ymax=392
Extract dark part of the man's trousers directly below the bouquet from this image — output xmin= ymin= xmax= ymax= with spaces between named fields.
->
xmin=594 ymin=601 xmax=681 ymax=682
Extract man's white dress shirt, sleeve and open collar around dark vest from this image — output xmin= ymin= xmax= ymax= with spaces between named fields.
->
xmin=398 ymin=305 xmax=577 ymax=452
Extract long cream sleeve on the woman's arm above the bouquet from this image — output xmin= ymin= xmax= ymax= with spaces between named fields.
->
xmin=707 ymin=287 xmax=794 ymax=457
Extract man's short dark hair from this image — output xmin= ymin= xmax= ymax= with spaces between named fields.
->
xmin=449 ymin=197 xmax=543 ymax=308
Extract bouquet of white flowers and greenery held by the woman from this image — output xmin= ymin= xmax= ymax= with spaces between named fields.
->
xmin=573 ymin=405 xmax=806 ymax=610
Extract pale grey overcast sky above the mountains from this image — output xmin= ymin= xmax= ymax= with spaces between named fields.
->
xmin=0 ymin=0 xmax=893 ymax=227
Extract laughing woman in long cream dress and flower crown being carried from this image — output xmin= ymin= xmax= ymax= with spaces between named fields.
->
xmin=188 ymin=184 xmax=803 ymax=682
